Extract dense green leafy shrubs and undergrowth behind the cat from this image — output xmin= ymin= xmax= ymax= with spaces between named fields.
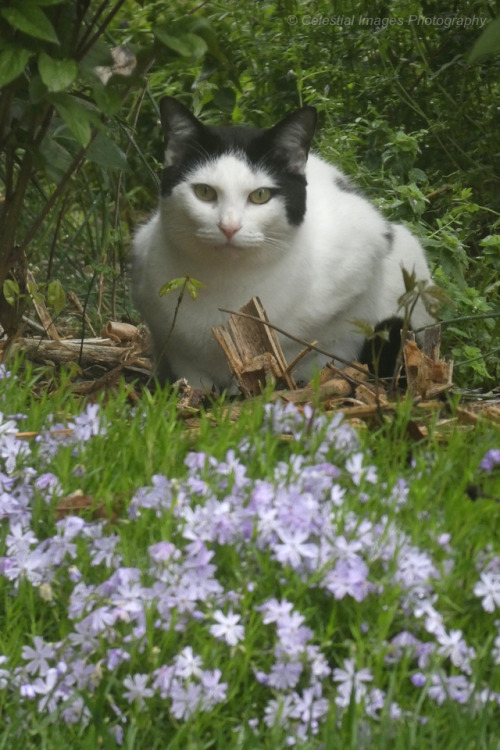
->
xmin=0 ymin=0 xmax=500 ymax=389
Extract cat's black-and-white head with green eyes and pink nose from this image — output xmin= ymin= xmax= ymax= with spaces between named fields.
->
xmin=160 ymin=97 xmax=316 ymax=258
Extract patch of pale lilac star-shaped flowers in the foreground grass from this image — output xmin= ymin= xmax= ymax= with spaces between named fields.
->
xmin=0 ymin=403 xmax=500 ymax=744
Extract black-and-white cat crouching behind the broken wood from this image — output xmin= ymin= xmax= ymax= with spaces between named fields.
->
xmin=132 ymin=97 xmax=431 ymax=389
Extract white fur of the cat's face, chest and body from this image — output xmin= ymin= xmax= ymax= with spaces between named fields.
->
xmin=133 ymin=155 xmax=430 ymax=388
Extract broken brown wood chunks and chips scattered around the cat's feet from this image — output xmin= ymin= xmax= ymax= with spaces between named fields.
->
xmin=0 ymin=297 xmax=500 ymax=437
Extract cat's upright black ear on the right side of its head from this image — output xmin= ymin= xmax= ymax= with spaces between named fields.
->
xmin=268 ymin=107 xmax=318 ymax=174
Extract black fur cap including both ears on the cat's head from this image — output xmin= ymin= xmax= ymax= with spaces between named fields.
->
xmin=160 ymin=97 xmax=316 ymax=225
